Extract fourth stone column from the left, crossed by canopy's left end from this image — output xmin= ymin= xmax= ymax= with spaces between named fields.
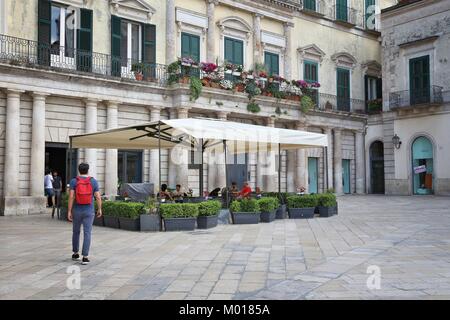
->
xmin=105 ymin=101 xmax=119 ymax=199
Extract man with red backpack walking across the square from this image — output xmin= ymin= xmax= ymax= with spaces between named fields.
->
xmin=68 ymin=163 xmax=102 ymax=265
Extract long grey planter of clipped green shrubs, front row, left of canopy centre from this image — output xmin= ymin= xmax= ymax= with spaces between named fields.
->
xmin=159 ymin=203 xmax=198 ymax=231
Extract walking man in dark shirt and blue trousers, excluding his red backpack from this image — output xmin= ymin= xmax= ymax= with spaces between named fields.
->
xmin=68 ymin=163 xmax=102 ymax=264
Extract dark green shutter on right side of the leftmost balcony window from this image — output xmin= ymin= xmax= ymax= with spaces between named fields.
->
xmin=77 ymin=9 xmax=92 ymax=72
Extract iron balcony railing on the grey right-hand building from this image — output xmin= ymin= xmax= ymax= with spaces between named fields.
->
xmin=389 ymin=86 xmax=444 ymax=109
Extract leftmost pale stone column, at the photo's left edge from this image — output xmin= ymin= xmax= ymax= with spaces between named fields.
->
xmin=3 ymin=90 xmax=23 ymax=198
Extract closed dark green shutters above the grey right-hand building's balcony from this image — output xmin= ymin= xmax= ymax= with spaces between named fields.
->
xmin=409 ymin=56 xmax=430 ymax=105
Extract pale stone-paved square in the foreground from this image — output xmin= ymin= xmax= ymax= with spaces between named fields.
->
xmin=0 ymin=196 xmax=450 ymax=300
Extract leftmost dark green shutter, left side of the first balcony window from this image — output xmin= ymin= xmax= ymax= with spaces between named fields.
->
xmin=37 ymin=0 xmax=52 ymax=66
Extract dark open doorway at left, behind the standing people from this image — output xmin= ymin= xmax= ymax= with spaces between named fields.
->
xmin=42 ymin=142 xmax=78 ymax=192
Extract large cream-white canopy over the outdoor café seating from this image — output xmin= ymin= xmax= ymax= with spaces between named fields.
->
xmin=70 ymin=118 xmax=328 ymax=153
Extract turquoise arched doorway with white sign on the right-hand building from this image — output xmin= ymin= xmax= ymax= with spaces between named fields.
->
xmin=411 ymin=137 xmax=433 ymax=194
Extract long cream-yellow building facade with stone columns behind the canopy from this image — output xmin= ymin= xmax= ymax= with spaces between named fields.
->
xmin=0 ymin=0 xmax=396 ymax=215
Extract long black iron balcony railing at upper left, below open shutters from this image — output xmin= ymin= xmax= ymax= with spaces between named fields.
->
xmin=0 ymin=35 xmax=167 ymax=85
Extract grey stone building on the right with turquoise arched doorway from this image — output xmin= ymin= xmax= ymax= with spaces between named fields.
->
xmin=366 ymin=0 xmax=450 ymax=195
